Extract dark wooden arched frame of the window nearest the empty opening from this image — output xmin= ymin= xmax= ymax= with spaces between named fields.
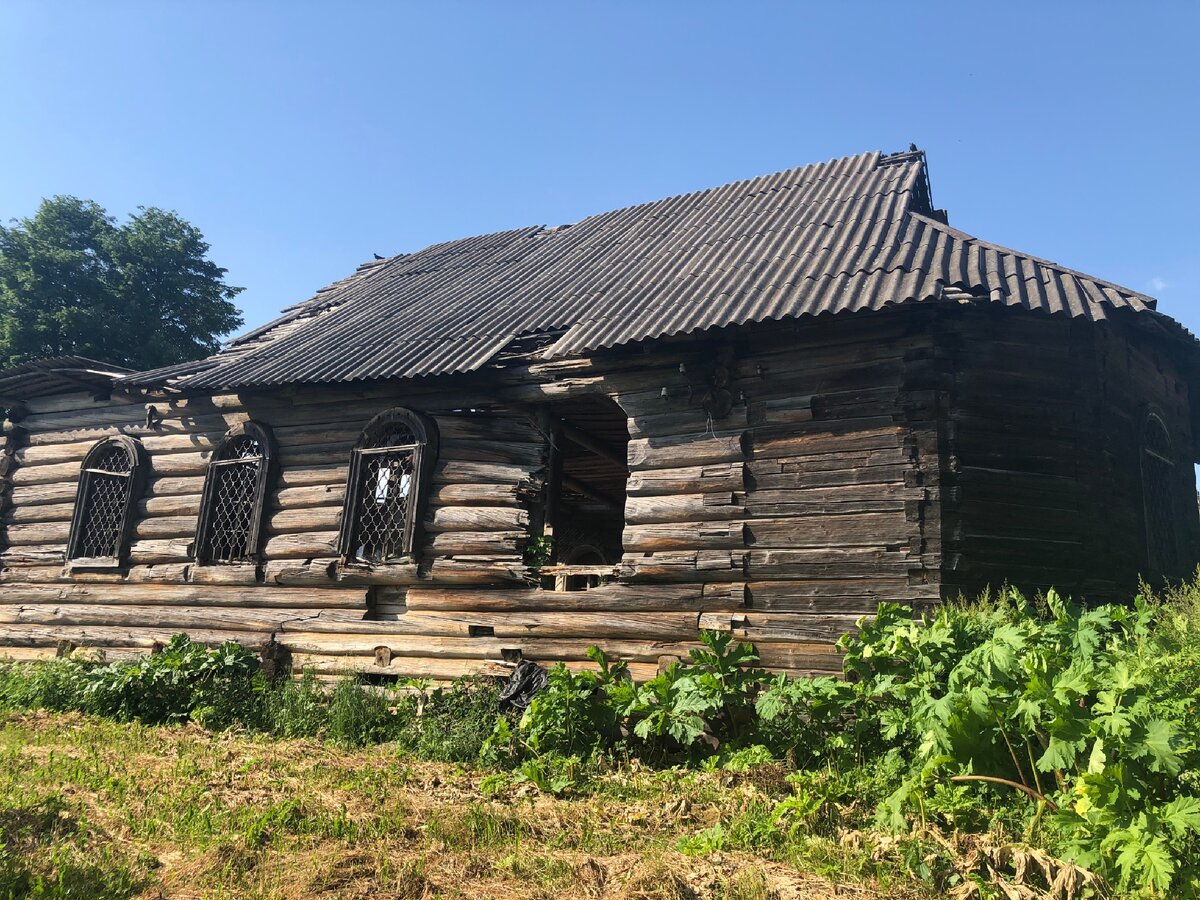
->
xmin=337 ymin=407 xmax=438 ymax=566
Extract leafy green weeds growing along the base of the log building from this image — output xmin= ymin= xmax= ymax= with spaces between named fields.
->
xmin=0 ymin=573 xmax=1200 ymax=900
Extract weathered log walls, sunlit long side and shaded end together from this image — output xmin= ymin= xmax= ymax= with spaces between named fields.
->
xmin=7 ymin=307 xmax=1200 ymax=680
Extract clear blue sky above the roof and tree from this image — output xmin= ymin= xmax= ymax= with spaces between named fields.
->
xmin=0 ymin=0 xmax=1200 ymax=331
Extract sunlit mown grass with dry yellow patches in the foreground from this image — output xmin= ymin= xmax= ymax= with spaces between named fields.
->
xmin=0 ymin=713 xmax=931 ymax=900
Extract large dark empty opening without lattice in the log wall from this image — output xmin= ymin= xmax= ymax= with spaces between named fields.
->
xmin=544 ymin=396 xmax=629 ymax=590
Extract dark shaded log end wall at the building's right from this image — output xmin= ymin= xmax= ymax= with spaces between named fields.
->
xmin=936 ymin=308 xmax=1200 ymax=600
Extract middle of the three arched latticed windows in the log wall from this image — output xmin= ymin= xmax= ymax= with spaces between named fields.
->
xmin=196 ymin=422 xmax=271 ymax=563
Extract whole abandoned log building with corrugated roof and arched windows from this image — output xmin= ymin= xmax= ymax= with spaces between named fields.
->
xmin=0 ymin=151 xmax=1200 ymax=680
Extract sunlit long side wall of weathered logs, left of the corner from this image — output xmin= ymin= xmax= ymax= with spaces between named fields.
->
xmin=0 ymin=314 xmax=938 ymax=680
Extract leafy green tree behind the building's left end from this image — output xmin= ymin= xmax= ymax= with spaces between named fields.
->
xmin=0 ymin=197 xmax=242 ymax=370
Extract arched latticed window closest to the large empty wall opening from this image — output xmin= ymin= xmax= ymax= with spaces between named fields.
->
xmin=341 ymin=409 xmax=437 ymax=563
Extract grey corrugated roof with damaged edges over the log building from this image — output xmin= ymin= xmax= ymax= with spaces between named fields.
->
xmin=117 ymin=151 xmax=1185 ymax=389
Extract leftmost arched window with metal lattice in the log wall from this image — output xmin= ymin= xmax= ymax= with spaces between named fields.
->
xmin=67 ymin=434 xmax=145 ymax=565
